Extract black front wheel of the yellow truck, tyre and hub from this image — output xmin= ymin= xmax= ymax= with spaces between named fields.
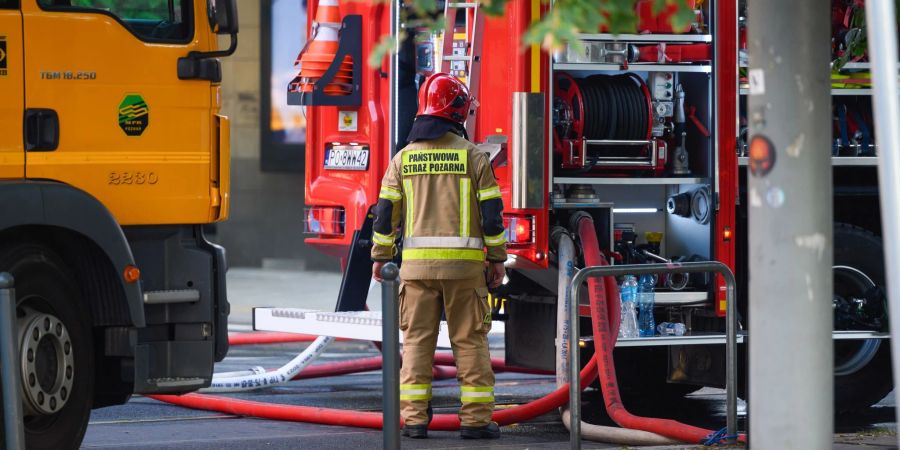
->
xmin=0 ymin=243 xmax=94 ymax=449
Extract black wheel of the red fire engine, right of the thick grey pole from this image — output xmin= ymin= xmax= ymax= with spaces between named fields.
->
xmin=833 ymin=224 xmax=893 ymax=413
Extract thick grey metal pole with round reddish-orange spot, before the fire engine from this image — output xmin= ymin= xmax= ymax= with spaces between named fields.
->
xmin=747 ymin=0 xmax=832 ymax=448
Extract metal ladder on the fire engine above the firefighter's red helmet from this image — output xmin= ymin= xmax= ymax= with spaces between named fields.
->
xmin=441 ymin=0 xmax=484 ymax=136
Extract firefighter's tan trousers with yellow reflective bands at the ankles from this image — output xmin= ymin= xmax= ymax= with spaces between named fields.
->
xmin=400 ymin=276 xmax=494 ymax=426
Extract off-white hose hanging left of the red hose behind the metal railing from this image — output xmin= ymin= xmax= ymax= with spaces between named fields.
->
xmin=556 ymin=233 xmax=681 ymax=445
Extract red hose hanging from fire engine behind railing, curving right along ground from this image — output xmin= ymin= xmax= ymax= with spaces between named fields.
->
xmin=578 ymin=216 xmax=744 ymax=444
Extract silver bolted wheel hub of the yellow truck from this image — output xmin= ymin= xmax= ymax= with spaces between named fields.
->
xmin=19 ymin=308 xmax=75 ymax=415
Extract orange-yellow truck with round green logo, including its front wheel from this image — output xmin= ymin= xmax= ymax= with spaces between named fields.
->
xmin=0 ymin=0 xmax=237 ymax=449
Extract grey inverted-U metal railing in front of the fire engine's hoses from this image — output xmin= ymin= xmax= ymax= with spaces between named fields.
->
xmin=568 ymin=261 xmax=737 ymax=450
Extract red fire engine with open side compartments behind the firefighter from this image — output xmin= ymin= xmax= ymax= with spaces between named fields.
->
xmin=288 ymin=0 xmax=892 ymax=411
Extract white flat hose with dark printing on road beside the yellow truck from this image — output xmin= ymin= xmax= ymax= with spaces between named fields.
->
xmin=200 ymin=336 xmax=334 ymax=393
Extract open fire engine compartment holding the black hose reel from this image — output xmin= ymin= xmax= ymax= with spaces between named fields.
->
xmin=536 ymin=3 xmax=720 ymax=309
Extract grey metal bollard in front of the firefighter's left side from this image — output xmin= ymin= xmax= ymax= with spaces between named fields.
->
xmin=381 ymin=263 xmax=400 ymax=450
